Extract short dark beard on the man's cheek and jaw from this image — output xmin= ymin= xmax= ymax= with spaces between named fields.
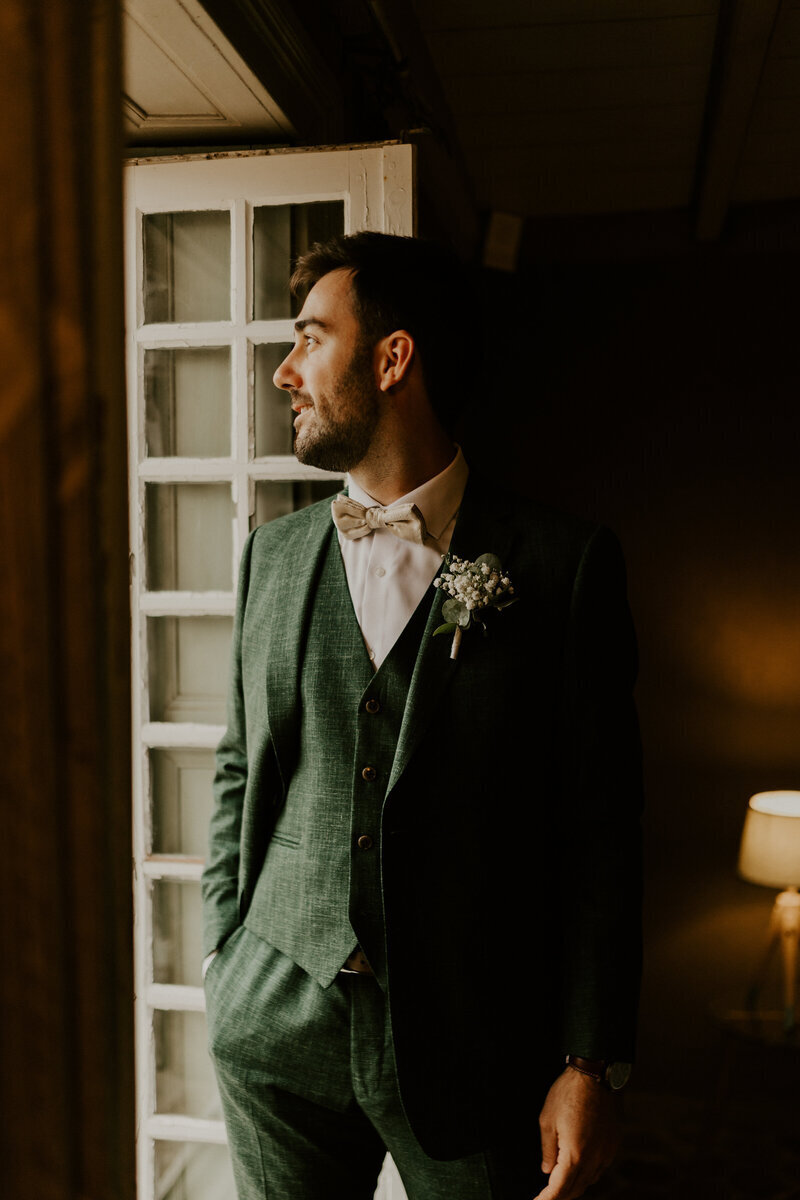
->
xmin=291 ymin=344 xmax=380 ymax=472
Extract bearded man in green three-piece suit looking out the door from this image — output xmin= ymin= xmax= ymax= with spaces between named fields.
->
xmin=203 ymin=233 xmax=640 ymax=1200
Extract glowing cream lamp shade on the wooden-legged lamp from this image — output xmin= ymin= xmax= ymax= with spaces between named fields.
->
xmin=739 ymin=792 xmax=800 ymax=888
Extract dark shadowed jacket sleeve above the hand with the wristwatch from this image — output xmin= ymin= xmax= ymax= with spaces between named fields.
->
xmin=561 ymin=529 xmax=642 ymax=1062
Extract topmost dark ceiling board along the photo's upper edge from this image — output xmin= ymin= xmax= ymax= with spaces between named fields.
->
xmin=416 ymin=0 xmax=719 ymax=31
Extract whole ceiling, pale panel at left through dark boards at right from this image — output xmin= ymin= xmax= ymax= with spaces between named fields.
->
xmin=125 ymin=0 xmax=800 ymax=246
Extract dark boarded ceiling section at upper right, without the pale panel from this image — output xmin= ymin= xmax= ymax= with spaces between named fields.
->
xmin=416 ymin=0 xmax=800 ymax=234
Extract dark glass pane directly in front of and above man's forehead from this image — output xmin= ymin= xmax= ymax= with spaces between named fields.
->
xmin=253 ymin=200 xmax=344 ymax=320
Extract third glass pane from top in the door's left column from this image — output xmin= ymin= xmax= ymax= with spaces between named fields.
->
xmin=145 ymin=484 xmax=236 ymax=592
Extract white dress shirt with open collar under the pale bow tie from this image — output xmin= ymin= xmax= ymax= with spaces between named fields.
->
xmin=338 ymin=446 xmax=469 ymax=671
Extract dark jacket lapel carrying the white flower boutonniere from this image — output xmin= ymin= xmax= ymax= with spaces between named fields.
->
xmin=386 ymin=475 xmax=513 ymax=794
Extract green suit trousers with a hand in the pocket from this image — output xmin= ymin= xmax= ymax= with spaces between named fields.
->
xmin=205 ymin=925 xmax=546 ymax=1200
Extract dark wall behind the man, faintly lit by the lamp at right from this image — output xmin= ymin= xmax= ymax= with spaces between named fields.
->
xmin=463 ymin=229 xmax=800 ymax=1094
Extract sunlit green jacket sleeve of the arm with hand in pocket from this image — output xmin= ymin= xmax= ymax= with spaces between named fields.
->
xmin=201 ymin=533 xmax=254 ymax=955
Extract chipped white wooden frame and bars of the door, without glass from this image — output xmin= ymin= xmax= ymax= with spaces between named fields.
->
xmin=125 ymin=143 xmax=415 ymax=1200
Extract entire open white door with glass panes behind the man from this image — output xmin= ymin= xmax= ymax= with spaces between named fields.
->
xmin=126 ymin=144 xmax=414 ymax=1200
